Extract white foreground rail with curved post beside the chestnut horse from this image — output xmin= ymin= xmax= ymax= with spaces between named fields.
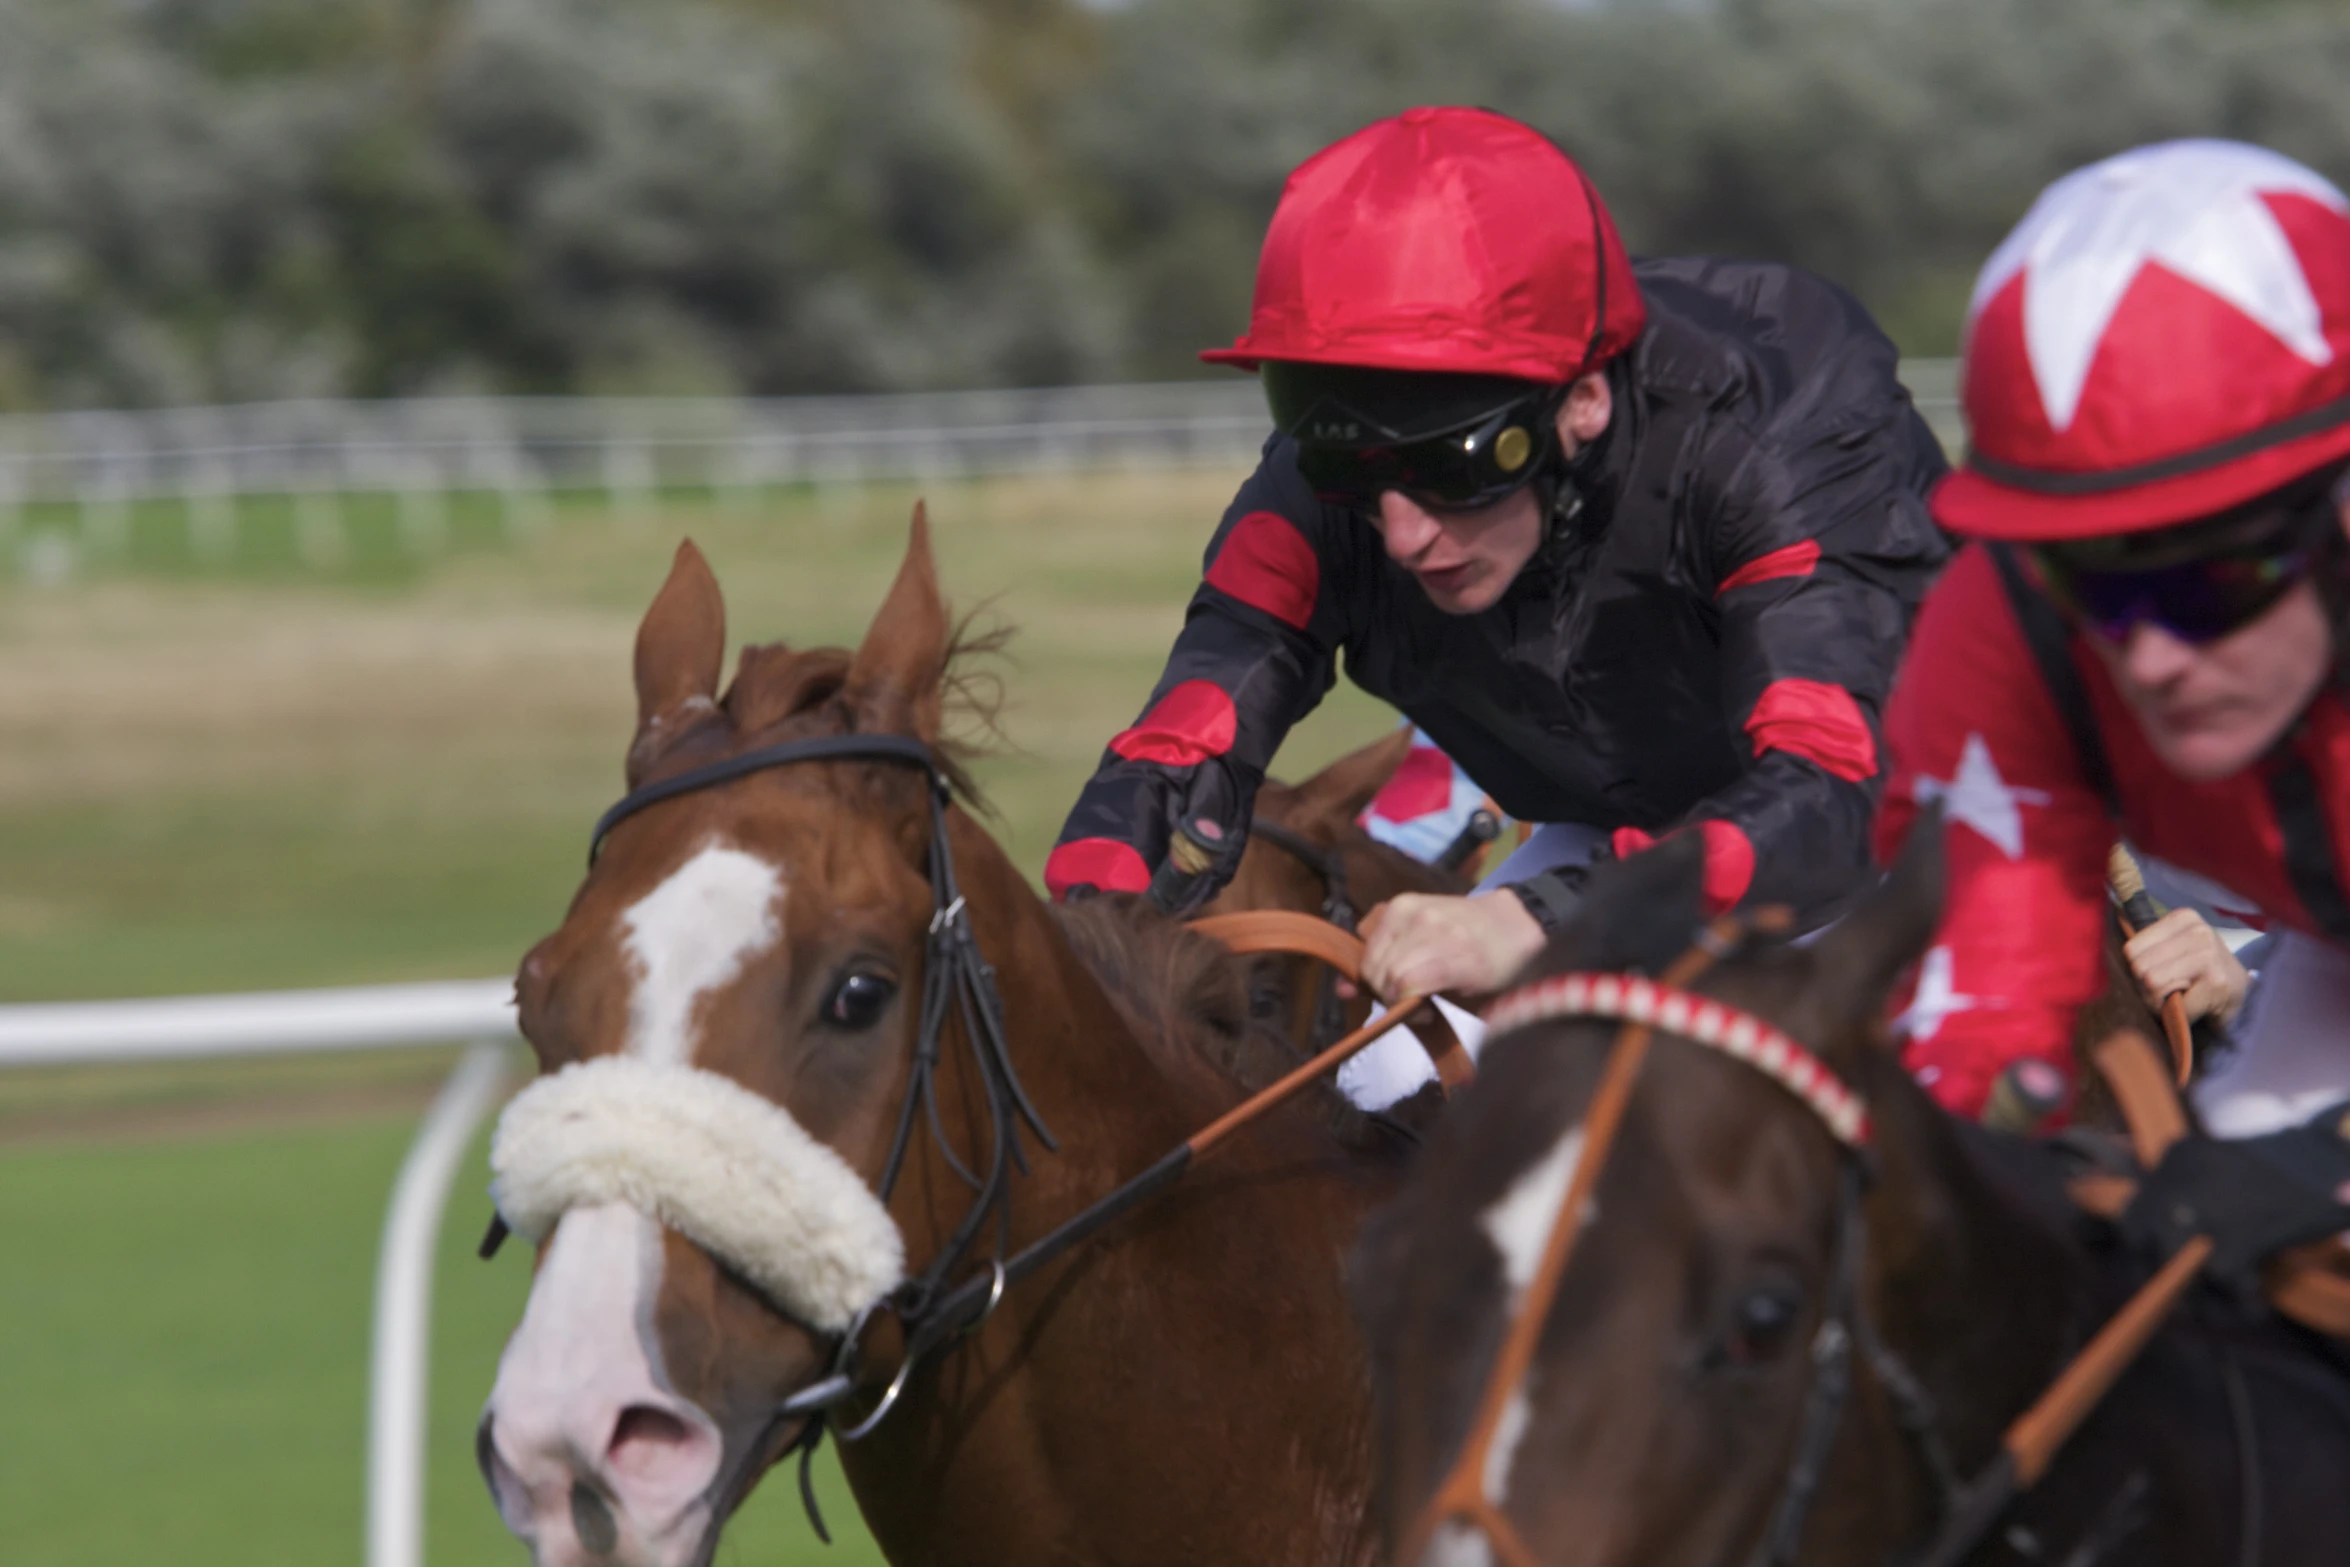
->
xmin=0 ymin=980 xmax=515 ymax=1567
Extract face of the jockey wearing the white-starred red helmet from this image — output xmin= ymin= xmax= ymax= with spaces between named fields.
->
xmin=2084 ymin=505 xmax=2350 ymax=782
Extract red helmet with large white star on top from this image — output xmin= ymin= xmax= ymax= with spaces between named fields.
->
xmin=1934 ymin=141 xmax=2350 ymax=540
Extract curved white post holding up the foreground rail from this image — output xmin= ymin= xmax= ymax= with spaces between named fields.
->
xmin=367 ymin=1041 xmax=505 ymax=1567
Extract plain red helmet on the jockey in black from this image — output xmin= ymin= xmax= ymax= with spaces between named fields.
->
xmin=1201 ymin=108 xmax=1647 ymax=383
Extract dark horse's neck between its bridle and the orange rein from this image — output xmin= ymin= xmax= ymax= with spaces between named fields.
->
xmin=1868 ymin=1062 xmax=2089 ymax=1464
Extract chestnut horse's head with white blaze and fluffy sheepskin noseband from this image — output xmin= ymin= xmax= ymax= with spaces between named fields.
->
xmin=479 ymin=512 xmax=982 ymax=1567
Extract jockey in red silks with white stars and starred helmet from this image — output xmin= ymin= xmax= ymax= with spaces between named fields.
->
xmin=1878 ymin=141 xmax=2350 ymax=1135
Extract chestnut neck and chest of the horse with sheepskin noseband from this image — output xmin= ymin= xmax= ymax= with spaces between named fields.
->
xmin=844 ymin=827 xmax=1370 ymax=1567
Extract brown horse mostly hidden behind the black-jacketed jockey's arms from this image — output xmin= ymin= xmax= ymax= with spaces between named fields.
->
xmin=1201 ymin=728 xmax=1469 ymax=1050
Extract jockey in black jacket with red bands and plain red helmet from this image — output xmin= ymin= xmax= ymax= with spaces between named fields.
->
xmin=1046 ymin=108 xmax=1948 ymax=996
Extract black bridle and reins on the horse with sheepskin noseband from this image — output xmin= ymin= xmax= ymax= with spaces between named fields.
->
xmin=524 ymin=735 xmax=1471 ymax=1544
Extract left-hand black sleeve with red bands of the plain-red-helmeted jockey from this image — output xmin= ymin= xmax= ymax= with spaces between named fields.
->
xmin=1043 ymin=437 xmax=1358 ymax=907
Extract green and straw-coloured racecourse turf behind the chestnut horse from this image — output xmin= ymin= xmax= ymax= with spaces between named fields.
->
xmin=0 ymin=472 xmax=1391 ymax=1567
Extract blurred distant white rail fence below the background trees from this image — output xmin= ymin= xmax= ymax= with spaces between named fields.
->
xmin=0 ymin=359 xmax=1962 ymax=566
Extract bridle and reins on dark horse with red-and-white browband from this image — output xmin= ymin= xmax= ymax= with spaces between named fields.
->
xmin=1398 ymin=909 xmax=2321 ymax=1567
